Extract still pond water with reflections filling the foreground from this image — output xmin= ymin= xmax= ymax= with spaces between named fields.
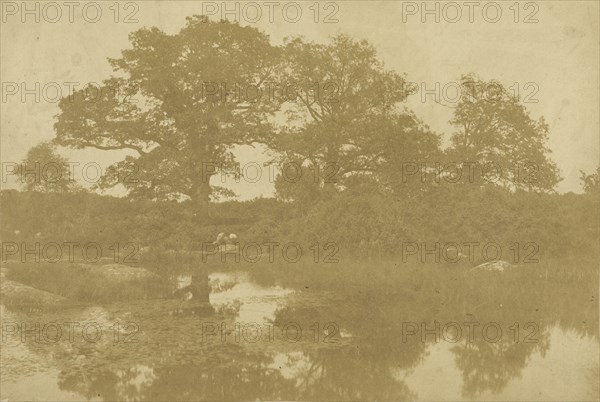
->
xmin=1 ymin=272 xmax=600 ymax=401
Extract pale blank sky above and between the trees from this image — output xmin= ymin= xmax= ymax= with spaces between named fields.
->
xmin=0 ymin=1 xmax=600 ymax=200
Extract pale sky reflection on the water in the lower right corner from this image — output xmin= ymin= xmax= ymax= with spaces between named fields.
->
xmin=406 ymin=327 xmax=598 ymax=401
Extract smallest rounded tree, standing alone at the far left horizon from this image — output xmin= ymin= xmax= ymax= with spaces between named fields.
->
xmin=16 ymin=142 xmax=80 ymax=193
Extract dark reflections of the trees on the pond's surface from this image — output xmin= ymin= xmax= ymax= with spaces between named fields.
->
xmin=2 ymin=262 xmax=598 ymax=400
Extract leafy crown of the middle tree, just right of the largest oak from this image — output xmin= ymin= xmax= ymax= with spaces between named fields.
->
xmin=274 ymin=35 xmax=414 ymax=195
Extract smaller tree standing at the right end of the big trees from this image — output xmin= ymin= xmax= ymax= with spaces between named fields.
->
xmin=447 ymin=75 xmax=562 ymax=192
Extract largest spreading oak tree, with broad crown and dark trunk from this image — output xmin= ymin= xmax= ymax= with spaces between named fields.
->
xmin=55 ymin=16 xmax=279 ymax=208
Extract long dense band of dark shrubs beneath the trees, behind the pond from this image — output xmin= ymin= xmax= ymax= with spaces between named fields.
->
xmin=0 ymin=186 xmax=600 ymax=262
